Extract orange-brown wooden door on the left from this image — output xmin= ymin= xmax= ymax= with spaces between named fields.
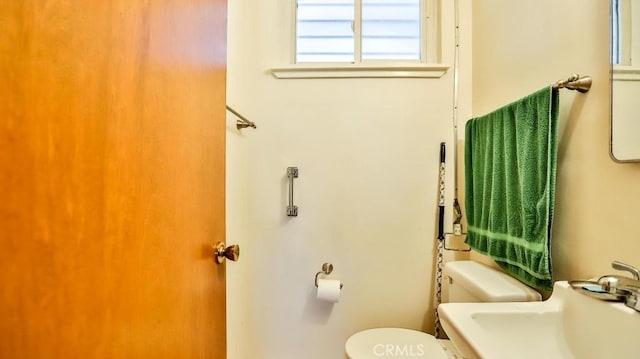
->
xmin=0 ymin=0 xmax=226 ymax=359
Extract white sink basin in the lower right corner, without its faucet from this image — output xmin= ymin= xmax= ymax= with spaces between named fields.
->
xmin=438 ymin=282 xmax=640 ymax=359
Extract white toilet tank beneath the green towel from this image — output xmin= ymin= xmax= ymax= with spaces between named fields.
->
xmin=443 ymin=261 xmax=542 ymax=303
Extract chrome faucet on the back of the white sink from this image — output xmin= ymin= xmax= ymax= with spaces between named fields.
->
xmin=598 ymin=261 xmax=640 ymax=312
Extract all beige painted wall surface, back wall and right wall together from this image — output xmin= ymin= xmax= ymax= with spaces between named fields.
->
xmin=227 ymin=0 xmax=640 ymax=359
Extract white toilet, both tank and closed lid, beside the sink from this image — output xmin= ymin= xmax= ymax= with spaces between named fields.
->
xmin=345 ymin=261 xmax=542 ymax=359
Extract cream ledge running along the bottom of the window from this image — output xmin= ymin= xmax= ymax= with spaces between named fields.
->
xmin=271 ymin=64 xmax=449 ymax=79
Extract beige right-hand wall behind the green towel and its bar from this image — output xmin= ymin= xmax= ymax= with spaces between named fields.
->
xmin=472 ymin=0 xmax=640 ymax=280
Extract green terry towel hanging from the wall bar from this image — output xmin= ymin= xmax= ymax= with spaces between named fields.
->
xmin=465 ymin=86 xmax=558 ymax=290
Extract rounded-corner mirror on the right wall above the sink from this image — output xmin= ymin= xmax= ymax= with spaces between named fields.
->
xmin=610 ymin=0 xmax=640 ymax=162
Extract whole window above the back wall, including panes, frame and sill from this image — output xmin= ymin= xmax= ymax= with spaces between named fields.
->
xmin=271 ymin=0 xmax=448 ymax=79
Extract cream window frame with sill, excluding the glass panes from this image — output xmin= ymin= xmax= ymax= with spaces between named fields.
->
xmin=271 ymin=0 xmax=449 ymax=79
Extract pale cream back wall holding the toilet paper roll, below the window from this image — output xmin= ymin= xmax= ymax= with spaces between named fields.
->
xmin=227 ymin=0 xmax=471 ymax=359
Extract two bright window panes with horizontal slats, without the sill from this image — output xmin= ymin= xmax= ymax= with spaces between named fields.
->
xmin=295 ymin=0 xmax=429 ymax=63
